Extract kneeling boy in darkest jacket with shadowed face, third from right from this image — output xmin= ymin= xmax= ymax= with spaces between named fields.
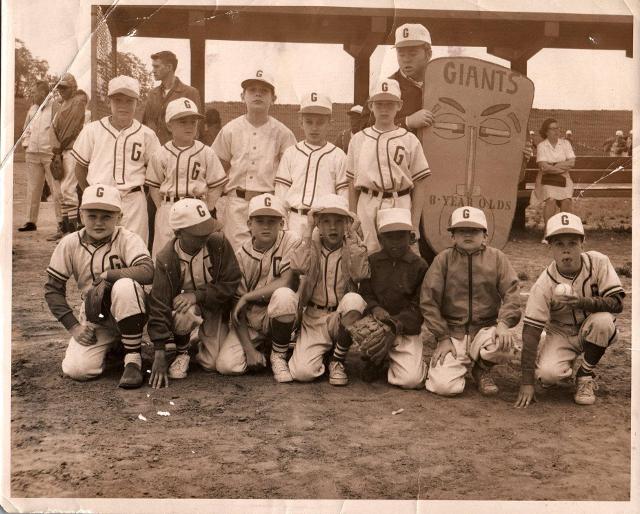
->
xmin=360 ymin=208 xmax=428 ymax=389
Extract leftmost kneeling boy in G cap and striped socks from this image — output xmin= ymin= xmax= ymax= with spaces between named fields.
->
xmin=44 ymin=184 xmax=153 ymax=389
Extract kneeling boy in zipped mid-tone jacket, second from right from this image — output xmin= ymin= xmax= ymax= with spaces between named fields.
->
xmin=420 ymin=207 xmax=520 ymax=396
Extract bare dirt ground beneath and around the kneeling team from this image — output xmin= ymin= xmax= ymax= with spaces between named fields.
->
xmin=11 ymin=164 xmax=631 ymax=501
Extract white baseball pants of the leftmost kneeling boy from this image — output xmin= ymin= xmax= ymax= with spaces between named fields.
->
xmin=62 ymin=278 xmax=146 ymax=380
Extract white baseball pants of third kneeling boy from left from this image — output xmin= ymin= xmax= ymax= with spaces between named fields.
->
xmin=216 ymin=287 xmax=299 ymax=375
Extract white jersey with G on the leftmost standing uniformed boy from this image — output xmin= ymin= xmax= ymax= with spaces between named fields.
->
xmin=71 ymin=116 xmax=160 ymax=191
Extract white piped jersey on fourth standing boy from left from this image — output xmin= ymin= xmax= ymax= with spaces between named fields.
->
xmin=275 ymin=141 xmax=349 ymax=209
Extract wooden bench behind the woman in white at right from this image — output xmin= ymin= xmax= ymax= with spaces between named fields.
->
xmin=513 ymin=156 xmax=633 ymax=228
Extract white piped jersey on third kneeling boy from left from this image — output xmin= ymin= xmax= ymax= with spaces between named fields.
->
xmin=236 ymin=230 xmax=301 ymax=298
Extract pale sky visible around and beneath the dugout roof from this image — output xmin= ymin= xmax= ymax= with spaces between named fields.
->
xmin=3 ymin=0 xmax=637 ymax=109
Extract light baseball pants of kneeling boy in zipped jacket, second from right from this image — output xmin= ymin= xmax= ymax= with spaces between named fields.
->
xmin=425 ymin=327 xmax=515 ymax=396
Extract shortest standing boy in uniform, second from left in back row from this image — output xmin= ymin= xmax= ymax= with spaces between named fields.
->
xmin=145 ymin=98 xmax=227 ymax=258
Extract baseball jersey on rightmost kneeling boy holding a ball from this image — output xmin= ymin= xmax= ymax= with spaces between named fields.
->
xmin=524 ymin=251 xmax=624 ymax=329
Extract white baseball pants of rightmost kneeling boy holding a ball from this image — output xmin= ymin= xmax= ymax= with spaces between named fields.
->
xmin=536 ymin=312 xmax=618 ymax=385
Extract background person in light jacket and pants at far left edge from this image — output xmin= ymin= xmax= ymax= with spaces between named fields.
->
xmin=18 ymin=80 xmax=64 ymax=241
